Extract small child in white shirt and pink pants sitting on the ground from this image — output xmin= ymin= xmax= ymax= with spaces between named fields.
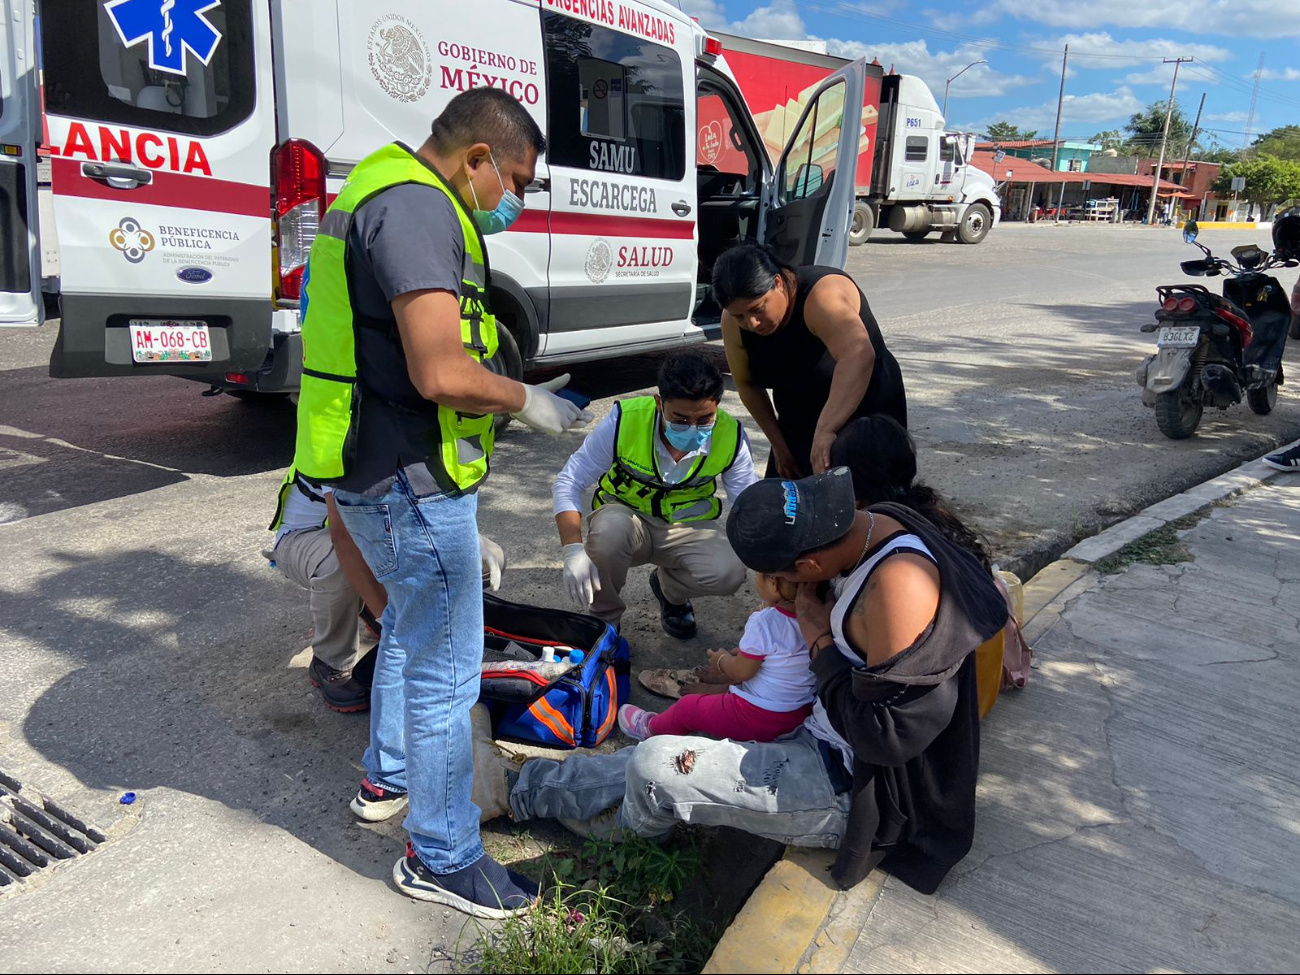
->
xmin=619 ymin=573 xmax=816 ymax=741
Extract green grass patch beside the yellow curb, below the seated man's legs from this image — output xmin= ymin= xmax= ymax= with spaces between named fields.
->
xmin=462 ymin=836 xmax=722 ymax=975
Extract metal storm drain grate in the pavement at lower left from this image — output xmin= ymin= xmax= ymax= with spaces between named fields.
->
xmin=0 ymin=770 xmax=108 ymax=889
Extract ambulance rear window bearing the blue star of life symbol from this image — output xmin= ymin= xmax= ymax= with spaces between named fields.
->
xmin=42 ymin=0 xmax=254 ymax=135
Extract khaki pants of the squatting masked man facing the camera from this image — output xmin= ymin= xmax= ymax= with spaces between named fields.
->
xmin=586 ymin=503 xmax=745 ymax=625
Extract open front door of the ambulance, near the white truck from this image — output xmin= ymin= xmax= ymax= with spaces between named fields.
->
xmin=761 ymin=59 xmax=867 ymax=268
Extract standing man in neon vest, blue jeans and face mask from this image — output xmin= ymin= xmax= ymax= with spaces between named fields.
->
xmin=294 ymin=88 xmax=590 ymax=918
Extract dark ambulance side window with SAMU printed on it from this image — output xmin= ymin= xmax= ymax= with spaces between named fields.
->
xmin=543 ymin=13 xmax=686 ymax=179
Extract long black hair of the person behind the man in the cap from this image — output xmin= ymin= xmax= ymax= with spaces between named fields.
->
xmin=831 ymin=413 xmax=991 ymax=568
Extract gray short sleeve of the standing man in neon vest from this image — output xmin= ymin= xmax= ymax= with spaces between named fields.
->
xmin=352 ymin=183 xmax=464 ymax=302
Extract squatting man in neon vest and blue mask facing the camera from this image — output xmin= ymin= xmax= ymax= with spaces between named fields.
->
xmin=554 ymin=350 xmax=758 ymax=640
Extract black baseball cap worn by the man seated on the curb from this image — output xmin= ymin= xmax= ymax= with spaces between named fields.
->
xmin=727 ymin=467 xmax=855 ymax=572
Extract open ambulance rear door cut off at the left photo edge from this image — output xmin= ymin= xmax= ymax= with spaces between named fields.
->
xmin=0 ymin=0 xmax=44 ymax=325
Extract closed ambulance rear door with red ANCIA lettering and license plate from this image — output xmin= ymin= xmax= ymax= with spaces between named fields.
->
xmin=42 ymin=0 xmax=276 ymax=377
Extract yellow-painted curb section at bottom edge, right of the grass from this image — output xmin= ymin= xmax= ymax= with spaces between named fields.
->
xmin=703 ymin=846 xmax=840 ymax=975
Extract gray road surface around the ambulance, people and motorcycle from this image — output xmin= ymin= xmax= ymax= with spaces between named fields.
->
xmin=0 ymin=226 xmax=1300 ymax=971
